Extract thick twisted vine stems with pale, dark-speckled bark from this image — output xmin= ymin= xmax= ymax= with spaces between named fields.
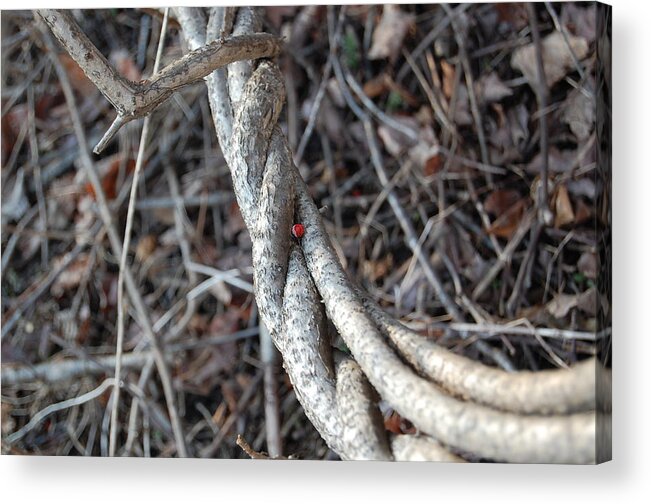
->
xmin=50 ymin=7 xmax=610 ymax=464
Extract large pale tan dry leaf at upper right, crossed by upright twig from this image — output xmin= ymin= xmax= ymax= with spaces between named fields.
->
xmin=511 ymin=31 xmax=588 ymax=87
